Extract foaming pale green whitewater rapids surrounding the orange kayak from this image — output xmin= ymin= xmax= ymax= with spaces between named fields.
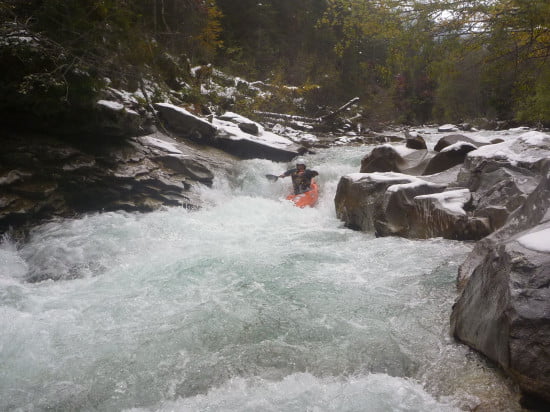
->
xmin=0 ymin=140 xmax=517 ymax=411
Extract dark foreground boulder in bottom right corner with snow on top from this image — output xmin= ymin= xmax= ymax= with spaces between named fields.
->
xmin=451 ymin=222 xmax=550 ymax=402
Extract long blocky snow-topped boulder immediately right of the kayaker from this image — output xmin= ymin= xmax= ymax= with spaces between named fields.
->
xmin=334 ymin=172 xmax=489 ymax=240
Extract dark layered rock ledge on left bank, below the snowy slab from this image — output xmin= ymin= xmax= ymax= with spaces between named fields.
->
xmin=0 ymin=134 xmax=229 ymax=238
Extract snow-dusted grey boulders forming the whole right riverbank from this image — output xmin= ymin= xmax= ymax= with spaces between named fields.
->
xmin=335 ymin=131 xmax=550 ymax=403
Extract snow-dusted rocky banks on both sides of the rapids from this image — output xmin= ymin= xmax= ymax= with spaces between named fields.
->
xmin=0 ymin=101 xmax=550 ymax=401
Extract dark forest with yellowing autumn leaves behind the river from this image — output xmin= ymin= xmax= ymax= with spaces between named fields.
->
xmin=0 ymin=0 xmax=550 ymax=132
